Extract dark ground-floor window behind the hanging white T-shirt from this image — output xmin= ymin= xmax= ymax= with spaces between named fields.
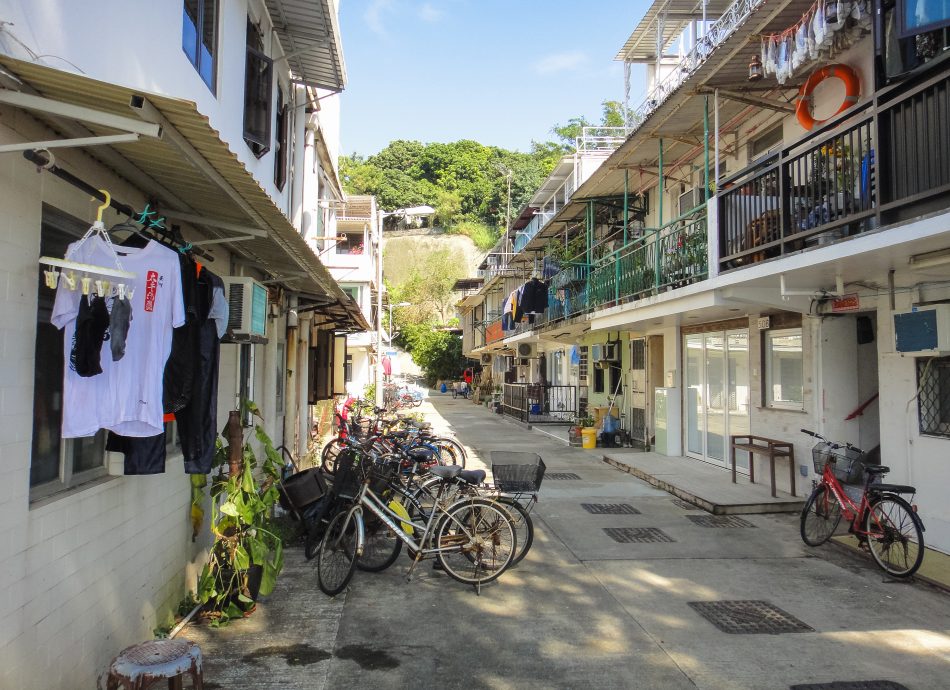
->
xmin=30 ymin=206 xmax=107 ymax=500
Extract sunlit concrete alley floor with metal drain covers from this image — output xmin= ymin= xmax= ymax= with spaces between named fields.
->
xmin=182 ymin=393 xmax=950 ymax=690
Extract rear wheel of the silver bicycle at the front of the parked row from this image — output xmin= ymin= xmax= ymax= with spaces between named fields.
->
xmin=436 ymin=498 xmax=518 ymax=585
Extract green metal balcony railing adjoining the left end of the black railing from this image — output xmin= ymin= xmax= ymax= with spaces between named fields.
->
xmin=588 ymin=205 xmax=709 ymax=307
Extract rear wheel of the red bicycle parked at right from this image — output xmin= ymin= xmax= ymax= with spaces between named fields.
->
xmin=864 ymin=496 xmax=924 ymax=577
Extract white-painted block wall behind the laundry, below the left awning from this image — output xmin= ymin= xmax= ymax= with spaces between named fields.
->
xmin=0 ymin=130 xmax=215 ymax=689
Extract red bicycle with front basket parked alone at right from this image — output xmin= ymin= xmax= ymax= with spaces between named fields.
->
xmin=801 ymin=429 xmax=924 ymax=577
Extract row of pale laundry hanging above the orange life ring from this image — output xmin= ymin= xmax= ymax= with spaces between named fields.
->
xmin=761 ymin=0 xmax=871 ymax=84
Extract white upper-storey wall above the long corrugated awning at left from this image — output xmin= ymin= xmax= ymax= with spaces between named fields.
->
xmin=0 ymin=0 xmax=302 ymax=210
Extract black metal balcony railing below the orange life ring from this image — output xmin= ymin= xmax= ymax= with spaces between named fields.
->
xmin=716 ymin=59 xmax=950 ymax=271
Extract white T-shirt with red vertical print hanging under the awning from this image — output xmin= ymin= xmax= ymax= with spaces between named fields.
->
xmin=50 ymin=236 xmax=185 ymax=438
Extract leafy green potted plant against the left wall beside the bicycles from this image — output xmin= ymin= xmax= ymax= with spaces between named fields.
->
xmin=198 ymin=403 xmax=284 ymax=625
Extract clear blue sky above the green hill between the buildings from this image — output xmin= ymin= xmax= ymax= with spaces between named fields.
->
xmin=340 ymin=0 xmax=649 ymax=155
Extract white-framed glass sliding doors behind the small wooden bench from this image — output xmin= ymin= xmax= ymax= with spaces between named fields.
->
xmin=683 ymin=328 xmax=749 ymax=472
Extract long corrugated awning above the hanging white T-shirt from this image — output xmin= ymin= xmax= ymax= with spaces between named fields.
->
xmin=0 ymin=56 xmax=369 ymax=329
